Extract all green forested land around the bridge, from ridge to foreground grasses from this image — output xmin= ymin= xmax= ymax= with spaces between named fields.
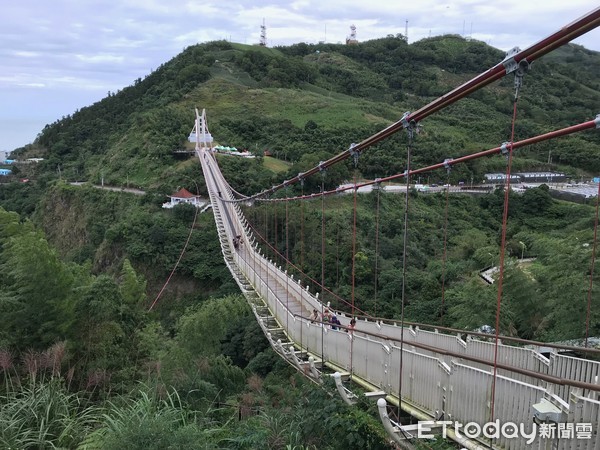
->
xmin=0 ymin=36 xmax=600 ymax=449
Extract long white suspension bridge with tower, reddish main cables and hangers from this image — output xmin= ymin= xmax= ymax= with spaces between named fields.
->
xmin=192 ymin=8 xmax=600 ymax=450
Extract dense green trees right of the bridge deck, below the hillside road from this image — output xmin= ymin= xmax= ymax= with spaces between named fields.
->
xmin=246 ymin=185 xmax=600 ymax=341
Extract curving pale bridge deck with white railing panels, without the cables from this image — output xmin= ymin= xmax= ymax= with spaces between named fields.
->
xmin=198 ymin=146 xmax=600 ymax=450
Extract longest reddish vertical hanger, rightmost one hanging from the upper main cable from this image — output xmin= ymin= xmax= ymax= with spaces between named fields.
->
xmin=490 ymin=72 xmax=524 ymax=422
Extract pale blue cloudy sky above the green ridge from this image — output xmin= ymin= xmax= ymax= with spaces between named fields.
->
xmin=0 ymin=0 xmax=600 ymax=150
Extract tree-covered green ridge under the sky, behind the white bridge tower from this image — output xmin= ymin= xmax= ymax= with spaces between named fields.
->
xmin=16 ymin=35 xmax=600 ymax=186
